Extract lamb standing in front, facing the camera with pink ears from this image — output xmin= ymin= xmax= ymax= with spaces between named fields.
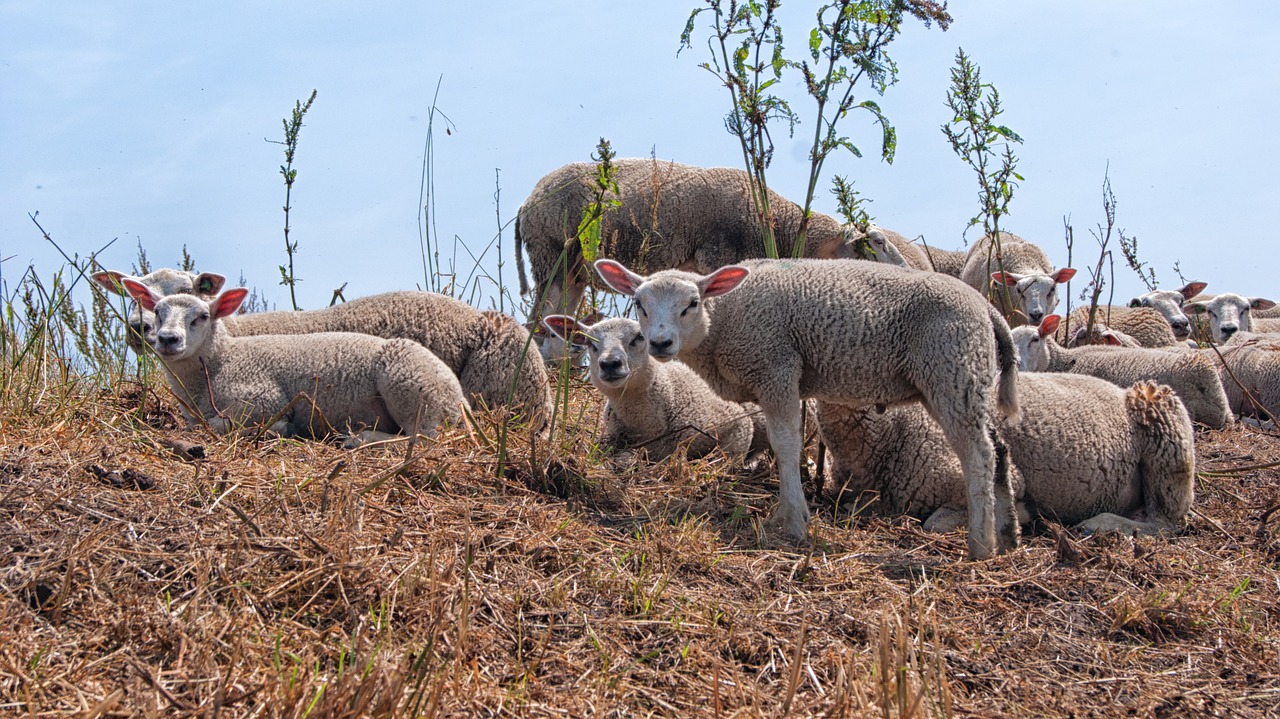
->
xmin=595 ymin=254 xmax=1018 ymax=558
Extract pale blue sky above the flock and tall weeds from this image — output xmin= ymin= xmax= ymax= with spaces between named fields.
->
xmin=0 ymin=0 xmax=1280 ymax=313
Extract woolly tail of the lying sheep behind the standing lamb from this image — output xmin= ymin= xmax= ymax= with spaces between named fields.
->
xmin=1125 ymin=381 xmax=1196 ymax=530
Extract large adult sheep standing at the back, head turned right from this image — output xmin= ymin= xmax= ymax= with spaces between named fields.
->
xmin=516 ymin=159 xmax=863 ymax=361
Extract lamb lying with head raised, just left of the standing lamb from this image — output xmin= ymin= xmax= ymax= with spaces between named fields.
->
xmin=543 ymin=315 xmax=764 ymax=461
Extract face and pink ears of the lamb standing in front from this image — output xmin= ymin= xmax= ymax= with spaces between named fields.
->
xmin=595 ymin=260 xmax=750 ymax=362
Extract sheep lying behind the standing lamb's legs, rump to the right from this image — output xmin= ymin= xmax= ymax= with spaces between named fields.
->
xmin=818 ymin=374 xmax=1196 ymax=533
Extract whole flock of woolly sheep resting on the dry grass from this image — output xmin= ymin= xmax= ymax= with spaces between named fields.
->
xmin=95 ymin=160 xmax=1280 ymax=558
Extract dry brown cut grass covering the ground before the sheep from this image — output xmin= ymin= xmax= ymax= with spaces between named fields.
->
xmin=0 ymin=376 xmax=1280 ymax=718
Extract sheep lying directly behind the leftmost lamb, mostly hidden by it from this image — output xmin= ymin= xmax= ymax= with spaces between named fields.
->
xmin=95 ymin=270 xmax=552 ymax=430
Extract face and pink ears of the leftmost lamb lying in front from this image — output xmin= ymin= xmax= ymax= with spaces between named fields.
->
xmin=122 ymin=278 xmax=248 ymax=361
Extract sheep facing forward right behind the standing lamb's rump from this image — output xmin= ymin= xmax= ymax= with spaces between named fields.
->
xmin=960 ymin=232 xmax=1075 ymax=328
